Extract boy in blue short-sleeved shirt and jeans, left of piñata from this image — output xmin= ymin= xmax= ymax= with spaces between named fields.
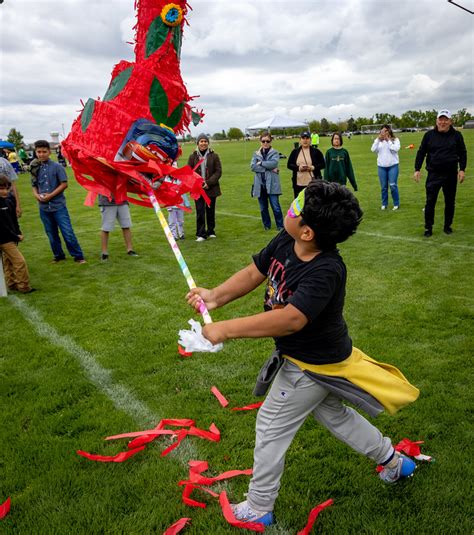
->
xmin=31 ymin=140 xmax=86 ymax=264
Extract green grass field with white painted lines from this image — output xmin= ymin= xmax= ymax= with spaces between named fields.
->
xmin=0 ymin=131 xmax=474 ymax=535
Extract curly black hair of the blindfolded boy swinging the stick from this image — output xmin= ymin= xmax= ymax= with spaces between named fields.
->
xmin=301 ymin=179 xmax=363 ymax=251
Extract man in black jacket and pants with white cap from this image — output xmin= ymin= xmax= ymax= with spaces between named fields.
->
xmin=413 ymin=110 xmax=467 ymax=238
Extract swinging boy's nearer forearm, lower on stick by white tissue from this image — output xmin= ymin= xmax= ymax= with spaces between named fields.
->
xmin=202 ymin=304 xmax=308 ymax=344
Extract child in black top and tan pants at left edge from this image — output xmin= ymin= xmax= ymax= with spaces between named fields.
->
xmin=0 ymin=174 xmax=35 ymax=294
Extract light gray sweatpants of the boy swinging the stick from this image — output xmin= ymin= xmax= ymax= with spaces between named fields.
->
xmin=247 ymin=360 xmax=393 ymax=511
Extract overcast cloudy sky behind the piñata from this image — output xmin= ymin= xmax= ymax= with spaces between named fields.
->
xmin=0 ymin=0 xmax=474 ymax=141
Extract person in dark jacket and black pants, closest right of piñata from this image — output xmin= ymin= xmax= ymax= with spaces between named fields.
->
xmin=188 ymin=134 xmax=222 ymax=242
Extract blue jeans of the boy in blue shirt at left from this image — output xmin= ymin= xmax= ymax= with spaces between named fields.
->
xmin=40 ymin=206 xmax=84 ymax=260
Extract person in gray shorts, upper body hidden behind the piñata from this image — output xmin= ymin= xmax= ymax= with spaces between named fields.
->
xmin=99 ymin=195 xmax=138 ymax=262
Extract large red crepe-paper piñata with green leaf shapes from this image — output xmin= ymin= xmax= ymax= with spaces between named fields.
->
xmin=62 ymin=0 xmax=203 ymax=207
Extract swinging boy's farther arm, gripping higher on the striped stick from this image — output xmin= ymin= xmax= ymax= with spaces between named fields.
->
xmin=186 ymin=263 xmax=266 ymax=311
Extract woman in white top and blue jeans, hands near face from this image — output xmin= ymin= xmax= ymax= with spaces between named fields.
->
xmin=370 ymin=124 xmax=400 ymax=210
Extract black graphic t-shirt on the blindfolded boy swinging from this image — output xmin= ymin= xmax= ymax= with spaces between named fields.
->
xmin=253 ymin=231 xmax=352 ymax=364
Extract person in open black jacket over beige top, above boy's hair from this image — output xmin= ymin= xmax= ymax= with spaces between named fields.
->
xmin=286 ymin=130 xmax=325 ymax=198
